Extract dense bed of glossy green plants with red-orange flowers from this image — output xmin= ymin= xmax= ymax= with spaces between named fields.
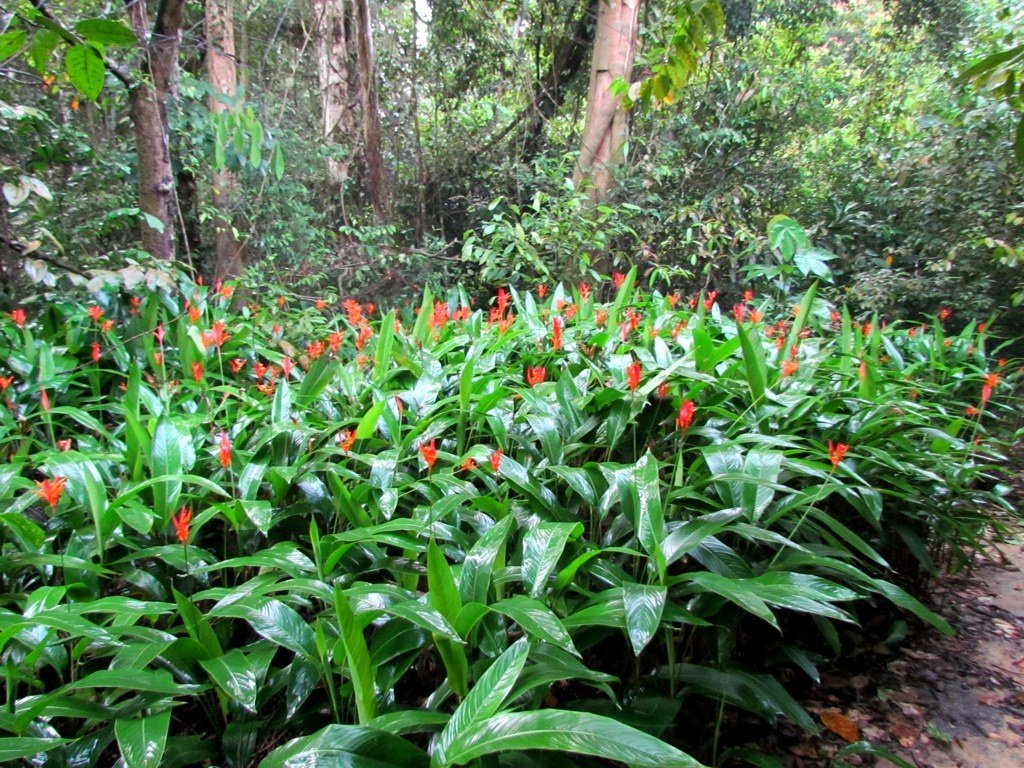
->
xmin=0 ymin=270 xmax=1020 ymax=768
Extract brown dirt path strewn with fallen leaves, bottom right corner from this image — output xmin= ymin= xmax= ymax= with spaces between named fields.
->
xmin=745 ymin=536 xmax=1024 ymax=768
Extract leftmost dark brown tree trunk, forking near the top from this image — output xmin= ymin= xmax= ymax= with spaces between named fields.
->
xmin=125 ymin=0 xmax=185 ymax=260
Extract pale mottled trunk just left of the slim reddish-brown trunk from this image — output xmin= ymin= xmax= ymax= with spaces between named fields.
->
xmin=313 ymin=0 xmax=355 ymax=196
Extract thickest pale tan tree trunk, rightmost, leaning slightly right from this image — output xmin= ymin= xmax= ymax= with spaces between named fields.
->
xmin=572 ymin=0 xmax=640 ymax=202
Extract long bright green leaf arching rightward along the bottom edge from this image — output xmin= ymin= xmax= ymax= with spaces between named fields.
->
xmin=431 ymin=710 xmax=700 ymax=768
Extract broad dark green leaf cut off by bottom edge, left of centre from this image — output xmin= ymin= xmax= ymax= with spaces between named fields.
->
xmin=259 ymin=725 xmax=429 ymax=768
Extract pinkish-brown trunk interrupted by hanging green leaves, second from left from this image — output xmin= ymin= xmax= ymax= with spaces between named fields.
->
xmin=206 ymin=0 xmax=246 ymax=278
